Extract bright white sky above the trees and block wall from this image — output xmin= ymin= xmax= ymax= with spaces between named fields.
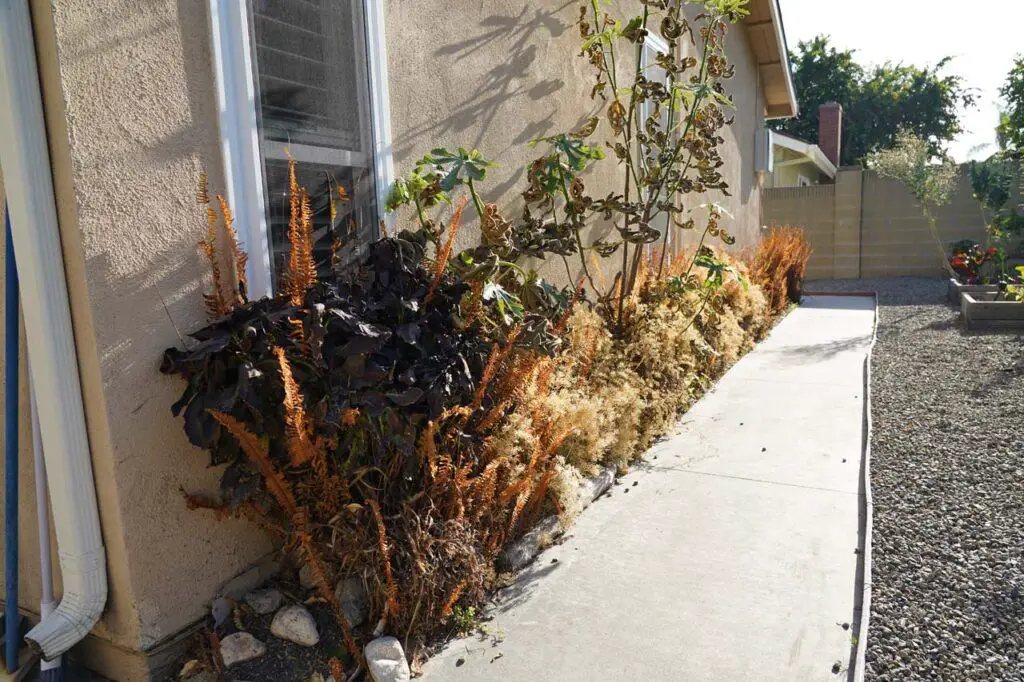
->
xmin=779 ymin=0 xmax=1024 ymax=162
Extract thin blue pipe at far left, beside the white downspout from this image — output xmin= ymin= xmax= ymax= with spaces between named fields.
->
xmin=4 ymin=202 xmax=22 ymax=673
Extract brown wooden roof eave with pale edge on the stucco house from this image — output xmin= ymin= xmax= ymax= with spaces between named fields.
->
xmin=743 ymin=0 xmax=800 ymax=119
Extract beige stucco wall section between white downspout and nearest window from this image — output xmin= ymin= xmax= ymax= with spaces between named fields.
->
xmin=36 ymin=0 xmax=270 ymax=650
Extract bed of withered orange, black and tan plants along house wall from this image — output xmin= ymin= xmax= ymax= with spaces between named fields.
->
xmin=162 ymin=0 xmax=810 ymax=680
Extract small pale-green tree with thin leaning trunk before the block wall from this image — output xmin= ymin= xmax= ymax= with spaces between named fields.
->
xmin=867 ymin=130 xmax=957 ymax=278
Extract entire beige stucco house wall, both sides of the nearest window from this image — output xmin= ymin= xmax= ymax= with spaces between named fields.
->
xmin=0 ymin=0 xmax=764 ymax=679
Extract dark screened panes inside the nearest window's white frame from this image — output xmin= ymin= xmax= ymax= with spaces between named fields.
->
xmin=250 ymin=0 xmax=378 ymax=280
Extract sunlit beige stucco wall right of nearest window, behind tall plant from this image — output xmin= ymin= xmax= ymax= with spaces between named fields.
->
xmin=385 ymin=0 xmax=764 ymax=283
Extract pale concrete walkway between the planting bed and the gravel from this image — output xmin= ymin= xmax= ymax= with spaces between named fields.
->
xmin=425 ymin=296 xmax=874 ymax=682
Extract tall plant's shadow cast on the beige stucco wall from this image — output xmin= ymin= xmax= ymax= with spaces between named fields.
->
xmin=394 ymin=0 xmax=575 ymax=166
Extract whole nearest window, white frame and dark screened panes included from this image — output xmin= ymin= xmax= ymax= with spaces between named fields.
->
xmin=209 ymin=0 xmax=391 ymax=296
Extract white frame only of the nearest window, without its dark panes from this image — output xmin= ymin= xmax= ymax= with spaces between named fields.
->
xmin=207 ymin=0 xmax=394 ymax=299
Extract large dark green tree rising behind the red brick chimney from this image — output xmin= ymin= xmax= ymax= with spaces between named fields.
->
xmin=773 ymin=36 xmax=974 ymax=165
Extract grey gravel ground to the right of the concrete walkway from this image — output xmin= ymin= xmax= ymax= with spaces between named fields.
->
xmin=807 ymin=278 xmax=1024 ymax=682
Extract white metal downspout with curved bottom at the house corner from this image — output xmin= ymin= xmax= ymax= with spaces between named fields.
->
xmin=0 ymin=0 xmax=106 ymax=659
